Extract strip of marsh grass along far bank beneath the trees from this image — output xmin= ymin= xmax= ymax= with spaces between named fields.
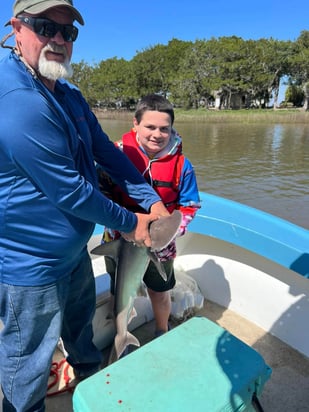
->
xmin=93 ymin=109 xmax=309 ymax=124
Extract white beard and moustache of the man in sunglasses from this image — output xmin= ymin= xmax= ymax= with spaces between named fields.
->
xmin=38 ymin=44 xmax=73 ymax=81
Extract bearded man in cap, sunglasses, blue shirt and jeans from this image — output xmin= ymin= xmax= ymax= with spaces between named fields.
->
xmin=0 ymin=0 xmax=168 ymax=412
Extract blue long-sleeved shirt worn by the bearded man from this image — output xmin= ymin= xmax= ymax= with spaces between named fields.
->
xmin=0 ymin=53 xmax=160 ymax=286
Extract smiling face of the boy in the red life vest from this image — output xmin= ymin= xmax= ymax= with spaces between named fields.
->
xmin=133 ymin=110 xmax=172 ymax=156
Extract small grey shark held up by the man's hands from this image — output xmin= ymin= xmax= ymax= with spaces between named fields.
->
xmin=91 ymin=210 xmax=182 ymax=364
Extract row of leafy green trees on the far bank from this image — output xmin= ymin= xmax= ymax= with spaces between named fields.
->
xmin=72 ymin=30 xmax=309 ymax=110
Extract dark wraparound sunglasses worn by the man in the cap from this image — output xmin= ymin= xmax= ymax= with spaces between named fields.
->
xmin=18 ymin=16 xmax=78 ymax=42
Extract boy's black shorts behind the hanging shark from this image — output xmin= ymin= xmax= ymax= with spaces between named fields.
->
xmin=104 ymin=256 xmax=176 ymax=295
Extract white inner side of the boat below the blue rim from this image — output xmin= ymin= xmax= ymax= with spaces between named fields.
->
xmin=175 ymin=233 xmax=309 ymax=357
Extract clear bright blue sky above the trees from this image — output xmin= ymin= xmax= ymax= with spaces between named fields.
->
xmin=0 ymin=0 xmax=309 ymax=100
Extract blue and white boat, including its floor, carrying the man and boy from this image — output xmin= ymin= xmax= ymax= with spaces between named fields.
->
xmin=0 ymin=193 xmax=309 ymax=412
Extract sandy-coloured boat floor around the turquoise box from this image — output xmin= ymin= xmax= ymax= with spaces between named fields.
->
xmin=0 ymin=301 xmax=309 ymax=412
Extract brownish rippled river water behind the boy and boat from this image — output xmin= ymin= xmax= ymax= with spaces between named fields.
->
xmin=102 ymin=120 xmax=309 ymax=229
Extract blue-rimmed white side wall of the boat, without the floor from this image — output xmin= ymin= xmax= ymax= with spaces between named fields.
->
xmin=89 ymin=193 xmax=309 ymax=357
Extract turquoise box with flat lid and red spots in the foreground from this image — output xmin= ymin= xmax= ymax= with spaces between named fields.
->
xmin=73 ymin=317 xmax=271 ymax=412
